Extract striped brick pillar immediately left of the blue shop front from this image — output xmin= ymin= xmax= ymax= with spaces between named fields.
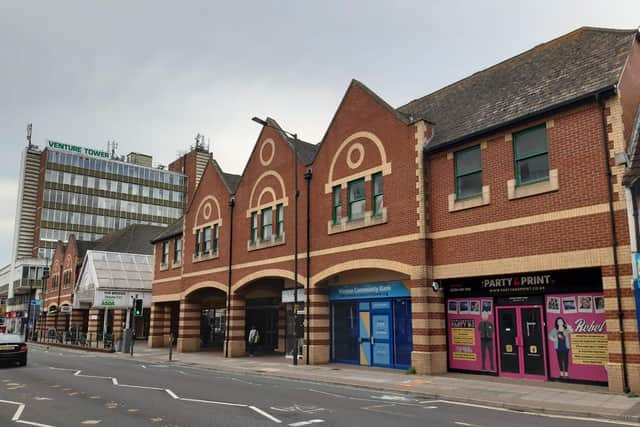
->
xmin=303 ymin=287 xmax=330 ymax=365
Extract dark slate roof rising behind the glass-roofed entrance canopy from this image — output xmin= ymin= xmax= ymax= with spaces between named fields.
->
xmin=92 ymin=224 xmax=167 ymax=255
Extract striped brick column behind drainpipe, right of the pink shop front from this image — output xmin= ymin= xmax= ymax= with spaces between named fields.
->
xmin=602 ymin=264 xmax=640 ymax=392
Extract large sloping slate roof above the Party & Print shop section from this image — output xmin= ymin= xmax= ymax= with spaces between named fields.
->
xmin=398 ymin=27 xmax=638 ymax=150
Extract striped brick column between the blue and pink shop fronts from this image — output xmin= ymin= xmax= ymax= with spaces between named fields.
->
xmin=405 ymin=279 xmax=447 ymax=375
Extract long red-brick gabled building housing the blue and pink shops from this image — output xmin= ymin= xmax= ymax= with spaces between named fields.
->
xmin=150 ymin=27 xmax=640 ymax=390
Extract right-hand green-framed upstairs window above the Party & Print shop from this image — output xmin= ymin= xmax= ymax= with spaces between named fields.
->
xmin=513 ymin=125 xmax=549 ymax=185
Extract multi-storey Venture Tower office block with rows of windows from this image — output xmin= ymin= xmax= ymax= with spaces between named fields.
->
xmin=5 ymin=141 xmax=188 ymax=333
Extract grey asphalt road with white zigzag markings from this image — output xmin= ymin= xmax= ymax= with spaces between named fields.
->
xmin=0 ymin=346 xmax=637 ymax=427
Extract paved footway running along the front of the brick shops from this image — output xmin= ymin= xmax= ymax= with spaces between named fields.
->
xmin=36 ymin=342 xmax=640 ymax=423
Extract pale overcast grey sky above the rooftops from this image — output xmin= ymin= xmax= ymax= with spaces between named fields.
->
xmin=0 ymin=0 xmax=640 ymax=266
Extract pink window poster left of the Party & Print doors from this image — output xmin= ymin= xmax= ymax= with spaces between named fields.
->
xmin=447 ymin=298 xmax=497 ymax=372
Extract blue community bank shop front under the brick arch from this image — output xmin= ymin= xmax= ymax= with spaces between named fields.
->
xmin=329 ymin=282 xmax=413 ymax=369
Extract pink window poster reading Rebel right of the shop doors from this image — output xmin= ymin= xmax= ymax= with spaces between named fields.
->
xmin=545 ymin=293 xmax=609 ymax=382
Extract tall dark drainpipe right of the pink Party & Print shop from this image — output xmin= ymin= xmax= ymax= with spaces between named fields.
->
xmin=596 ymin=95 xmax=630 ymax=393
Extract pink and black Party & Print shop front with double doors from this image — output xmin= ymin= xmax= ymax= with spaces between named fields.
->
xmin=443 ymin=268 xmax=609 ymax=384
